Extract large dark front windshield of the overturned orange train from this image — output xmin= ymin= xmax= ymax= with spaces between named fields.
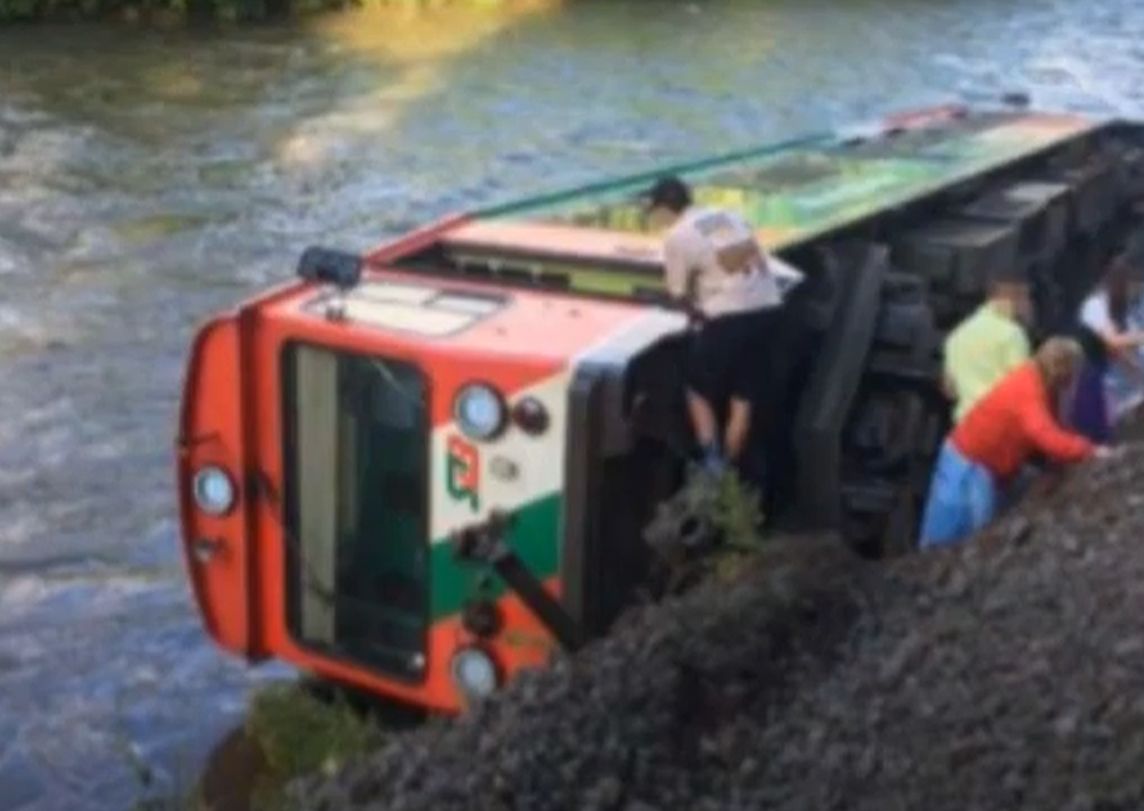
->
xmin=283 ymin=344 xmax=429 ymax=679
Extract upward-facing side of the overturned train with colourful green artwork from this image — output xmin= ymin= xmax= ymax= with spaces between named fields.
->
xmin=370 ymin=105 xmax=1109 ymax=297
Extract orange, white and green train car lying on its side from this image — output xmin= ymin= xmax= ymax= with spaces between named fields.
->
xmin=177 ymin=108 xmax=1144 ymax=713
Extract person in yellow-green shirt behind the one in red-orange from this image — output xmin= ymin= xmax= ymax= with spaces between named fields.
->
xmin=943 ymin=270 xmax=1032 ymax=423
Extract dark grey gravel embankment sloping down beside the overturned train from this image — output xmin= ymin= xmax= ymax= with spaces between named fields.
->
xmin=294 ymin=447 xmax=1144 ymax=811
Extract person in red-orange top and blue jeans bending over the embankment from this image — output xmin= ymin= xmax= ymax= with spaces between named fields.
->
xmin=920 ymin=337 xmax=1109 ymax=547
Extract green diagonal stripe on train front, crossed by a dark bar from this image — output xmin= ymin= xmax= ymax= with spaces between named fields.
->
xmin=429 ymin=493 xmax=563 ymax=622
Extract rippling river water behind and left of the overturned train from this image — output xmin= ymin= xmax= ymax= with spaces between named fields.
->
xmin=0 ymin=0 xmax=1144 ymax=811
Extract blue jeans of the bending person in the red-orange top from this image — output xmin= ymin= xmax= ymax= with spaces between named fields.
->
xmin=920 ymin=439 xmax=998 ymax=549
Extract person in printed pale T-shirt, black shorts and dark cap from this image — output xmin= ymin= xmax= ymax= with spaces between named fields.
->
xmin=645 ymin=176 xmax=782 ymax=471
